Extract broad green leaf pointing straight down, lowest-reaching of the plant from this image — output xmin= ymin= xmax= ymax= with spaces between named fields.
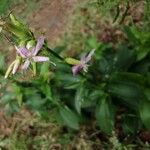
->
xmin=96 ymin=96 xmax=114 ymax=134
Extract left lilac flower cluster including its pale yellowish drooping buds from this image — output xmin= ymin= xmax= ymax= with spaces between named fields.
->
xmin=5 ymin=36 xmax=56 ymax=78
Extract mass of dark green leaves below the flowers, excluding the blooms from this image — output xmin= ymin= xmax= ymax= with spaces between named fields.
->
xmin=1 ymin=21 xmax=150 ymax=134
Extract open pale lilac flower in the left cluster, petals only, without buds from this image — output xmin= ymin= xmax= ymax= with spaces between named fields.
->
xmin=15 ymin=36 xmax=52 ymax=70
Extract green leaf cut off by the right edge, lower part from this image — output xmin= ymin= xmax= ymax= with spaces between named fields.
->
xmin=139 ymin=100 xmax=150 ymax=130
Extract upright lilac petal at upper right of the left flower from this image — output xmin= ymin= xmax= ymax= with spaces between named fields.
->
xmin=32 ymin=36 xmax=45 ymax=56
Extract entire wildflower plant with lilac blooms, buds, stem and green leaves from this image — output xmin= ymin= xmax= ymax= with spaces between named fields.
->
xmin=0 ymin=14 xmax=150 ymax=134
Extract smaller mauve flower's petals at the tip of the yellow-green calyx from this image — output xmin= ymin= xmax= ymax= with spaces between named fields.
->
xmin=72 ymin=49 xmax=95 ymax=75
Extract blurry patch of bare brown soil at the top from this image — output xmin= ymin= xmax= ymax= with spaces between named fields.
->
xmin=29 ymin=0 xmax=79 ymax=46
